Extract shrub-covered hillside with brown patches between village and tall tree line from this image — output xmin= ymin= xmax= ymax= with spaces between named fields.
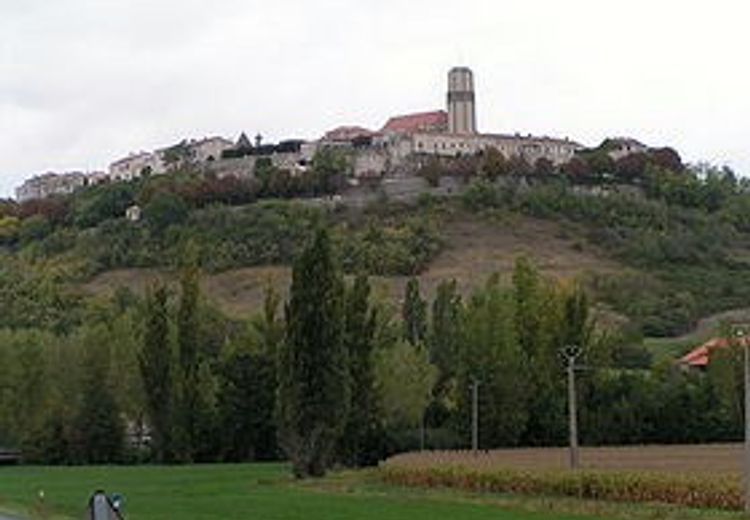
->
xmin=0 ymin=165 xmax=750 ymax=341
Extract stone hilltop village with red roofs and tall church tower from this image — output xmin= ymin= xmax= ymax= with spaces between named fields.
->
xmin=16 ymin=67 xmax=648 ymax=202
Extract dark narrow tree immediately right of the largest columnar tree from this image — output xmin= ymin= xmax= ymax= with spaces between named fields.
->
xmin=340 ymin=274 xmax=383 ymax=466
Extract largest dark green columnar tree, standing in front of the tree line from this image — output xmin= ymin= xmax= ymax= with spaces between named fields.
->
xmin=278 ymin=227 xmax=350 ymax=478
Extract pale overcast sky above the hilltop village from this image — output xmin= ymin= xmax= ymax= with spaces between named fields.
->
xmin=0 ymin=0 xmax=750 ymax=196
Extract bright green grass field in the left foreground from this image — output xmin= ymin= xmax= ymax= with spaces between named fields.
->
xmin=0 ymin=464 xmax=594 ymax=520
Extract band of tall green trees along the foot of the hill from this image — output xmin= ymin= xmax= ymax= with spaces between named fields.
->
xmin=0 ymin=226 xmax=742 ymax=477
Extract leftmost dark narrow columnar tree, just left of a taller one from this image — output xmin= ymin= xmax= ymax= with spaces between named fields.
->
xmin=138 ymin=284 xmax=174 ymax=462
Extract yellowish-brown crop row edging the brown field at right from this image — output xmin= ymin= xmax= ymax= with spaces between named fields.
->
xmin=379 ymin=465 xmax=742 ymax=509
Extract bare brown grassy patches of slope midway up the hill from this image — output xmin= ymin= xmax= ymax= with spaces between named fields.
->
xmin=80 ymin=215 xmax=624 ymax=318
